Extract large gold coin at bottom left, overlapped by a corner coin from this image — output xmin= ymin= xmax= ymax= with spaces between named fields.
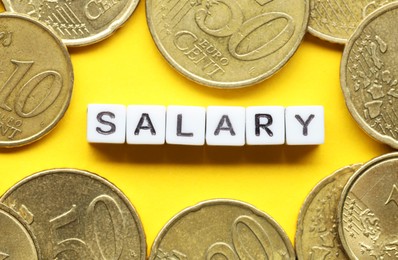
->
xmin=0 ymin=169 xmax=146 ymax=260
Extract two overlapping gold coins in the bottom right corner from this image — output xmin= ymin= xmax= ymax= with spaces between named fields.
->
xmin=296 ymin=153 xmax=398 ymax=260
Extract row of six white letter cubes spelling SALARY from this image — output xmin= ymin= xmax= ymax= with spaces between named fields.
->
xmin=87 ymin=104 xmax=324 ymax=146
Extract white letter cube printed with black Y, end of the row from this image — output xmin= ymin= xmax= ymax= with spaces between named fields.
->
xmin=285 ymin=106 xmax=325 ymax=145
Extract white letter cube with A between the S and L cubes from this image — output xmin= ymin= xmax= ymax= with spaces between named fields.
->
xmin=126 ymin=105 xmax=166 ymax=144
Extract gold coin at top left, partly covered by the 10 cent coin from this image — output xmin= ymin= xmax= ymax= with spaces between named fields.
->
xmin=3 ymin=0 xmax=139 ymax=46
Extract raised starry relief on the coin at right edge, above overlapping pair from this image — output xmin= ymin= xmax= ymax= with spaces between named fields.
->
xmin=348 ymin=32 xmax=398 ymax=139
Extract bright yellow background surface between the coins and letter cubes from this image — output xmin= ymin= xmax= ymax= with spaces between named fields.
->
xmin=0 ymin=1 xmax=392 ymax=256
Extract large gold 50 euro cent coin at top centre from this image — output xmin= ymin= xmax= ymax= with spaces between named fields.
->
xmin=146 ymin=0 xmax=309 ymax=88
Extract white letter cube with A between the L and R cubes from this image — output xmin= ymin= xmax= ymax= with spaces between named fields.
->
xmin=206 ymin=106 xmax=246 ymax=146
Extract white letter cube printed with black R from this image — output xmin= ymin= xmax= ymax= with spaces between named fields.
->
xmin=246 ymin=106 xmax=285 ymax=145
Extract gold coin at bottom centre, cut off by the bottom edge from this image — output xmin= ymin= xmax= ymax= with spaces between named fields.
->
xmin=149 ymin=199 xmax=295 ymax=260
